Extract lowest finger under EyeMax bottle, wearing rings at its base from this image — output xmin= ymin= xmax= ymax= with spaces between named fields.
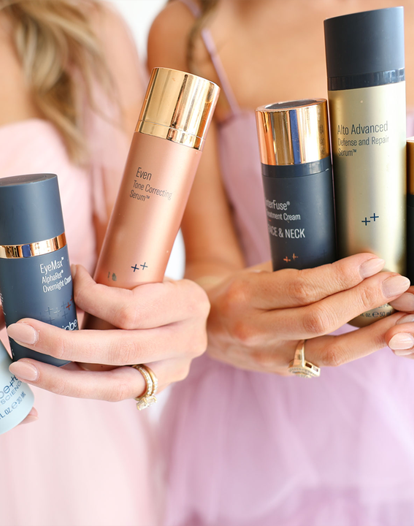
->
xmin=9 ymin=358 xmax=190 ymax=402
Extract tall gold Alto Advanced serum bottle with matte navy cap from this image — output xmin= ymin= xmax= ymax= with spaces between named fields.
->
xmin=325 ymin=7 xmax=406 ymax=327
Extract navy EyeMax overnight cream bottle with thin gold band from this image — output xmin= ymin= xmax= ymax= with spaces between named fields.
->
xmin=0 ymin=174 xmax=78 ymax=366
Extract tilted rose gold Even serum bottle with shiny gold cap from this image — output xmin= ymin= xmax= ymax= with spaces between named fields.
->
xmin=85 ymin=68 xmax=220 ymax=329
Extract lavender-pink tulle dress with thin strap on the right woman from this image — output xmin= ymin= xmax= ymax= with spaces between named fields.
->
xmin=163 ymin=2 xmax=414 ymax=526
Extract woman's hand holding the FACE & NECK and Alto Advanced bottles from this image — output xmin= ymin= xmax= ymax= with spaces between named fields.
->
xmin=208 ymin=254 xmax=414 ymax=375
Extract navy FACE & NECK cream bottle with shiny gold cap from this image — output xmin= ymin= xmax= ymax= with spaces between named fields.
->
xmin=256 ymin=99 xmax=335 ymax=270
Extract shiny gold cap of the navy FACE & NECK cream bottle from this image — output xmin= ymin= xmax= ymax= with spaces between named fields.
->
xmin=256 ymin=99 xmax=330 ymax=166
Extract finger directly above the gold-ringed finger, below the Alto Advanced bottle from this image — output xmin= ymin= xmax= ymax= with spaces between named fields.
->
xmin=258 ymin=272 xmax=410 ymax=340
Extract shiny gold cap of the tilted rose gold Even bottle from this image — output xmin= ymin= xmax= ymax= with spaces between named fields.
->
xmin=135 ymin=68 xmax=220 ymax=150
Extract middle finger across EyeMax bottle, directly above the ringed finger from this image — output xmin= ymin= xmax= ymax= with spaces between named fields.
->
xmin=7 ymin=319 xmax=207 ymax=365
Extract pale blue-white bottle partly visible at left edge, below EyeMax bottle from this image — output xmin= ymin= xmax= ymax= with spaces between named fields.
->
xmin=0 ymin=341 xmax=34 ymax=435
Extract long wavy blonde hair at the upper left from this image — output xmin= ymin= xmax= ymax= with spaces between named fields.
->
xmin=2 ymin=0 xmax=112 ymax=163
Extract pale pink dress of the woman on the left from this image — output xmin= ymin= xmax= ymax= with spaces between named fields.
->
xmin=0 ymin=20 xmax=162 ymax=526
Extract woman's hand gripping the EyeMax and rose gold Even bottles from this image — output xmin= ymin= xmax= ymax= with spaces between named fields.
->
xmin=7 ymin=266 xmax=209 ymax=401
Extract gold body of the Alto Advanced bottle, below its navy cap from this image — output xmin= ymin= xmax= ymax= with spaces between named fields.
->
xmin=329 ymin=82 xmax=406 ymax=274
